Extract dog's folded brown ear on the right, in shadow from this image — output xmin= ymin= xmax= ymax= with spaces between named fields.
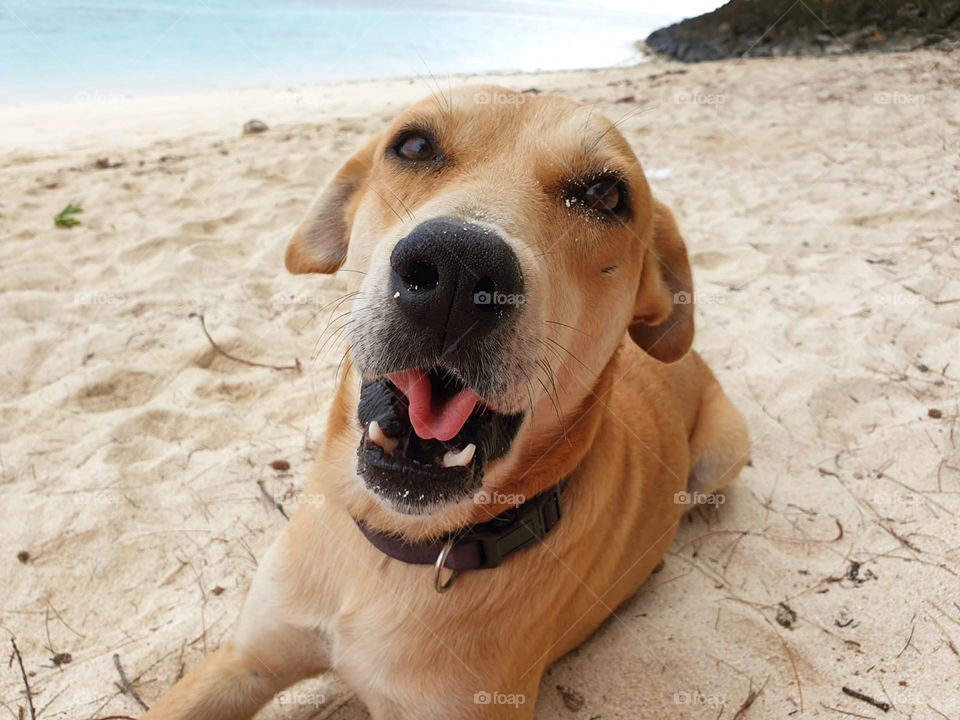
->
xmin=630 ymin=200 xmax=693 ymax=362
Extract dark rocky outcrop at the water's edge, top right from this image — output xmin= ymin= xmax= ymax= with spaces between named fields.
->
xmin=639 ymin=0 xmax=960 ymax=62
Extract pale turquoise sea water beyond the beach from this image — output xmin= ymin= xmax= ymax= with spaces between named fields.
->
xmin=0 ymin=0 xmax=704 ymax=103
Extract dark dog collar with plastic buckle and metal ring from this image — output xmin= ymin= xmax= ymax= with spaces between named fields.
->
xmin=354 ymin=480 xmax=566 ymax=570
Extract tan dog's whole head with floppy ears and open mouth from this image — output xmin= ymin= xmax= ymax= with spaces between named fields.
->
xmin=286 ymin=87 xmax=693 ymax=514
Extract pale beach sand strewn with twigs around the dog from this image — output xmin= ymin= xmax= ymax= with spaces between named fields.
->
xmin=0 ymin=52 xmax=960 ymax=720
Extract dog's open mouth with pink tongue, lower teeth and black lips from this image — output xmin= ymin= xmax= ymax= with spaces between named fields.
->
xmin=357 ymin=366 xmax=523 ymax=513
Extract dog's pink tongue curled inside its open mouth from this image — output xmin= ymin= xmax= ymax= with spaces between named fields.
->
xmin=388 ymin=368 xmax=480 ymax=442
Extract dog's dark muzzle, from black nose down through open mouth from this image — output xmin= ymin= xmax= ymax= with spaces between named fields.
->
xmin=354 ymin=218 xmax=524 ymax=513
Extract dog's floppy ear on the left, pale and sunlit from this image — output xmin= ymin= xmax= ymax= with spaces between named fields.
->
xmin=285 ymin=137 xmax=379 ymax=275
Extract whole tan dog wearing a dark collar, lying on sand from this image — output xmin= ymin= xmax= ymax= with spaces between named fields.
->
xmin=145 ymin=87 xmax=749 ymax=720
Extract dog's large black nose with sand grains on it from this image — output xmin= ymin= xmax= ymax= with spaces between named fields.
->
xmin=390 ymin=218 xmax=524 ymax=350
